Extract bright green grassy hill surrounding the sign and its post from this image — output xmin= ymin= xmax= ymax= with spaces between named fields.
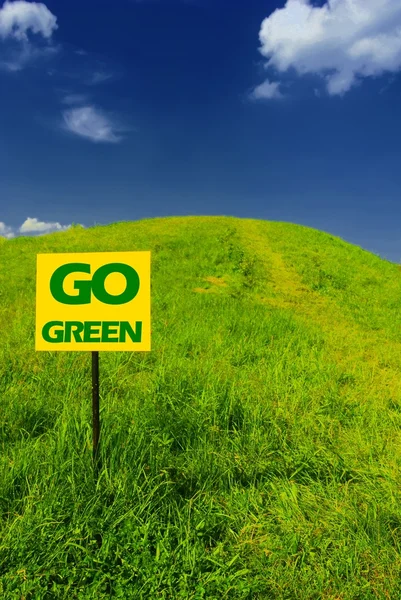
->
xmin=0 ymin=216 xmax=401 ymax=600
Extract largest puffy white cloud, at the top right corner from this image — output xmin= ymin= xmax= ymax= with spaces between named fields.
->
xmin=256 ymin=0 xmax=401 ymax=95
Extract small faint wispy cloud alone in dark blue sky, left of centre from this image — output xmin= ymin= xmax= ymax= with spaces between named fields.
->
xmin=63 ymin=106 xmax=122 ymax=142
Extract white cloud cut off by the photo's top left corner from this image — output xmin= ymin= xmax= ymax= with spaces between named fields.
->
xmin=0 ymin=0 xmax=58 ymax=41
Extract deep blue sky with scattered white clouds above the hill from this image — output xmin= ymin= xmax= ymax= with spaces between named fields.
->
xmin=0 ymin=0 xmax=401 ymax=263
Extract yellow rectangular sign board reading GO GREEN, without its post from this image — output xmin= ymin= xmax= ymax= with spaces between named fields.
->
xmin=35 ymin=251 xmax=150 ymax=352
